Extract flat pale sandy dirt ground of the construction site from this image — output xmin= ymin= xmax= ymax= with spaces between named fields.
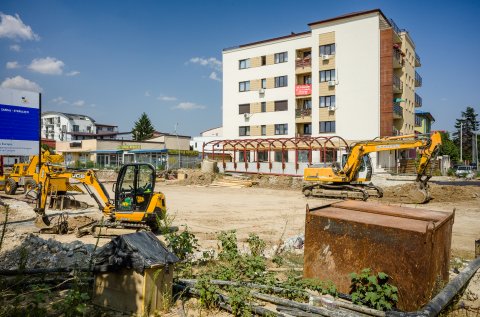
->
xmin=0 ymin=175 xmax=480 ymax=314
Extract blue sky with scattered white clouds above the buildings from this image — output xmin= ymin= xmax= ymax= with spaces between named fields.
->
xmin=0 ymin=0 xmax=480 ymax=135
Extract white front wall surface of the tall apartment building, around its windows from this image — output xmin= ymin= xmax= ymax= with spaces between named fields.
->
xmin=223 ymin=13 xmax=380 ymax=140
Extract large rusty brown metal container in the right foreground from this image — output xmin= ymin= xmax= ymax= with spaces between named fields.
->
xmin=304 ymin=200 xmax=454 ymax=311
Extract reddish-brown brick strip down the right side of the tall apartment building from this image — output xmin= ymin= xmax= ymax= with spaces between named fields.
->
xmin=380 ymin=29 xmax=393 ymax=137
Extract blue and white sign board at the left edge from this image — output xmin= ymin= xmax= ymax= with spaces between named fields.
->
xmin=0 ymin=88 xmax=40 ymax=155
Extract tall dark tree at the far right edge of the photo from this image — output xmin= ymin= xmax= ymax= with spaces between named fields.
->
xmin=453 ymin=107 xmax=480 ymax=161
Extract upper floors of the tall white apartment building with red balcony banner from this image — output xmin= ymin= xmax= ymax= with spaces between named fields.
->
xmin=223 ymin=9 xmax=422 ymax=166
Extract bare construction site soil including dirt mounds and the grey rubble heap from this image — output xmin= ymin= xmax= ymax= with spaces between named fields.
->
xmin=0 ymin=170 xmax=480 ymax=316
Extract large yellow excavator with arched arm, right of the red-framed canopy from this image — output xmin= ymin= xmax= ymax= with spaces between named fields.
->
xmin=302 ymin=132 xmax=442 ymax=204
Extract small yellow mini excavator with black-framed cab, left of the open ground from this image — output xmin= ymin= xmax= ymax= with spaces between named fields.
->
xmin=35 ymin=163 xmax=167 ymax=236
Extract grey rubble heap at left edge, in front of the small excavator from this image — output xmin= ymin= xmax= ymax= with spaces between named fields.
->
xmin=0 ymin=233 xmax=95 ymax=270
